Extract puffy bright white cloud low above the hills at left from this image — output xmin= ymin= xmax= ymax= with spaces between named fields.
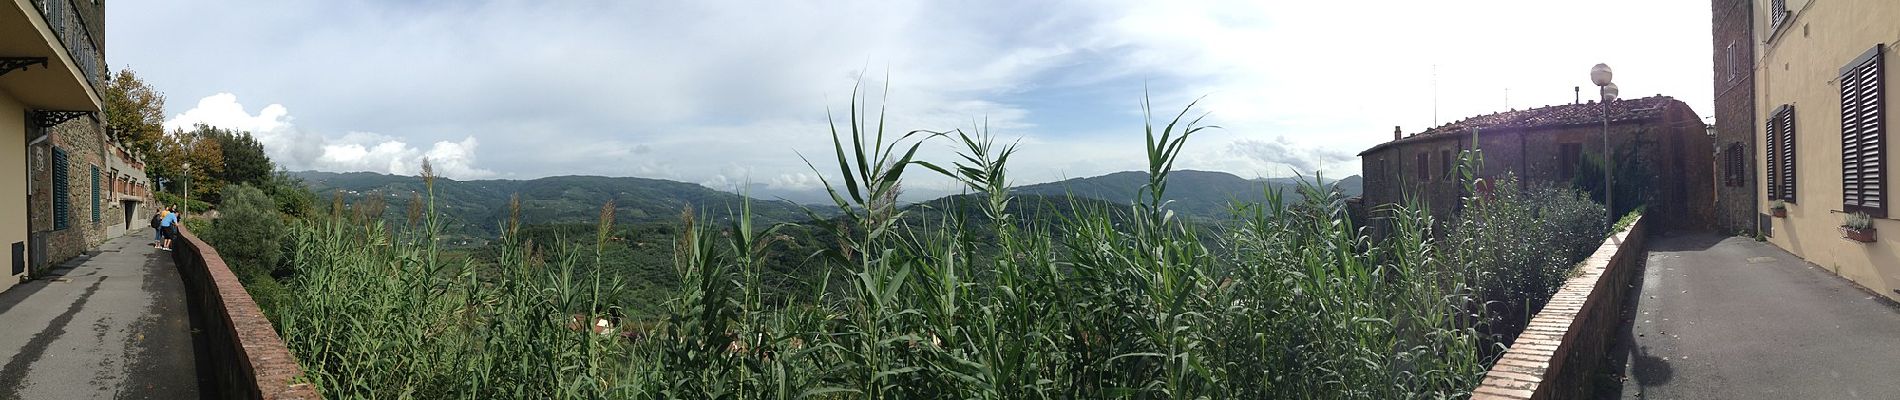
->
xmin=165 ymin=93 xmax=496 ymax=178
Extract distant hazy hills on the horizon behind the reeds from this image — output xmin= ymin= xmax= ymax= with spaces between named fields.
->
xmin=291 ymin=171 xmax=1362 ymax=237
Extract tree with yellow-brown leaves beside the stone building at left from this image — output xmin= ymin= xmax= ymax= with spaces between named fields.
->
xmin=105 ymin=70 xmax=165 ymax=157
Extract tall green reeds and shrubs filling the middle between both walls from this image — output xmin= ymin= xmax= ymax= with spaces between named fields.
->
xmin=229 ymin=88 xmax=1604 ymax=398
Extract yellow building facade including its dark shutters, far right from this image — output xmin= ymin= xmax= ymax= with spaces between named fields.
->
xmin=1748 ymin=0 xmax=1900 ymax=300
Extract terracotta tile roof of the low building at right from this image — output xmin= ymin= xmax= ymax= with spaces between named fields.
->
xmin=1360 ymin=95 xmax=1682 ymax=155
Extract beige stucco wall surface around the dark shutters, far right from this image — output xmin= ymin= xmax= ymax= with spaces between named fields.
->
xmin=1754 ymin=0 xmax=1900 ymax=300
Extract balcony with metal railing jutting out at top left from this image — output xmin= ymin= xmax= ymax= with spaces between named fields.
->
xmin=0 ymin=0 xmax=105 ymax=112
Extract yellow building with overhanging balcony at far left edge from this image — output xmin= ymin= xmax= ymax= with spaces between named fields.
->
xmin=0 ymin=0 xmax=105 ymax=288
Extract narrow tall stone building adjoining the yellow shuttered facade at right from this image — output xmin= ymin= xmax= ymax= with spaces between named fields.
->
xmin=1710 ymin=0 xmax=1759 ymax=235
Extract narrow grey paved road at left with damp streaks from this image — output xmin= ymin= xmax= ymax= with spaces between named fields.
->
xmin=0 ymin=235 xmax=200 ymax=398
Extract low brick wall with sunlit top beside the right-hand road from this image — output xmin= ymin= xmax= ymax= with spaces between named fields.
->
xmin=1471 ymin=216 xmax=1651 ymax=400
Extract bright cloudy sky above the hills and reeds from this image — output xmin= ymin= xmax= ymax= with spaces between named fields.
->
xmin=106 ymin=0 xmax=1714 ymax=200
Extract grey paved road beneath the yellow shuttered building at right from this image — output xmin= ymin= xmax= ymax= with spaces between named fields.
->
xmin=1621 ymin=235 xmax=1900 ymax=398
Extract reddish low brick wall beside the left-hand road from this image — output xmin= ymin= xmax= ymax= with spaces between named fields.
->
xmin=171 ymin=226 xmax=321 ymax=400
